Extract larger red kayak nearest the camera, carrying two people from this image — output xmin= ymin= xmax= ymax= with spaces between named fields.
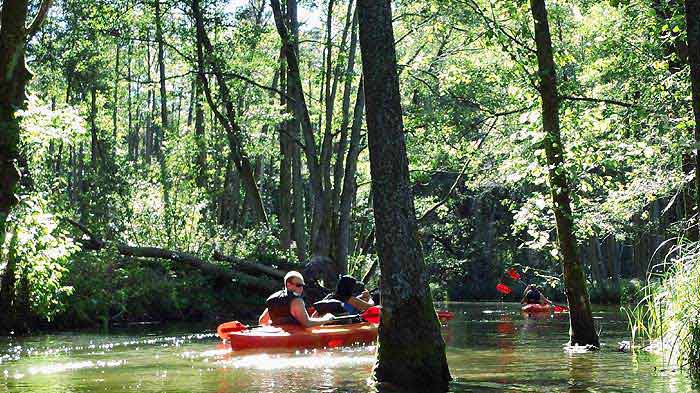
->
xmin=228 ymin=322 xmax=377 ymax=350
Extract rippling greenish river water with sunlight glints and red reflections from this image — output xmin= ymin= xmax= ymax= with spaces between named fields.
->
xmin=0 ymin=303 xmax=697 ymax=393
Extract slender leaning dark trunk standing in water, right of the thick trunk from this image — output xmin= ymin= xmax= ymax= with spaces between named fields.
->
xmin=530 ymin=0 xmax=600 ymax=347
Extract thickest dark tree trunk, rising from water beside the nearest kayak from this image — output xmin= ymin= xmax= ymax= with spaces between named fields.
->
xmin=357 ymin=0 xmax=451 ymax=391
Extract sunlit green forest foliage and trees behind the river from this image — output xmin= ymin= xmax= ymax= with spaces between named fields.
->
xmin=0 ymin=0 xmax=696 ymax=334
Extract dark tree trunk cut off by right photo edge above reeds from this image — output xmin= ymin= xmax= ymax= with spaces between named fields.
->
xmin=685 ymin=0 xmax=700 ymax=239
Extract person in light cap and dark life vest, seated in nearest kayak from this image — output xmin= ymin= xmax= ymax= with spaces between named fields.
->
xmin=258 ymin=270 xmax=333 ymax=327
